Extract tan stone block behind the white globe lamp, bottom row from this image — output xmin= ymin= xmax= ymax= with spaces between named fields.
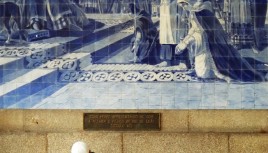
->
xmin=48 ymin=132 xmax=122 ymax=153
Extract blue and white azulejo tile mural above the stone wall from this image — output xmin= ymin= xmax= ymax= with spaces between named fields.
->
xmin=0 ymin=0 xmax=268 ymax=109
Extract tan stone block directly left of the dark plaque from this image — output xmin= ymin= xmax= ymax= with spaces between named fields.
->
xmin=24 ymin=110 xmax=83 ymax=132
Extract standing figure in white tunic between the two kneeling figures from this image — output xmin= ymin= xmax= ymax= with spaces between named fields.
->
xmin=157 ymin=0 xmax=188 ymax=67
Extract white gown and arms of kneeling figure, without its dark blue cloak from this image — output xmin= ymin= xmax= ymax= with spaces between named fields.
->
xmin=176 ymin=4 xmax=231 ymax=82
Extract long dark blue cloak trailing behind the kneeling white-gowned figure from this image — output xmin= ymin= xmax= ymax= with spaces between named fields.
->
xmin=177 ymin=1 xmax=264 ymax=82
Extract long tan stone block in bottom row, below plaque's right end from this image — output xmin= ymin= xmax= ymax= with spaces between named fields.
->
xmin=123 ymin=133 xmax=228 ymax=153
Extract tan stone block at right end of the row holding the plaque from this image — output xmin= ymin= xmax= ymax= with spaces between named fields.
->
xmin=189 ymin=110 xmax=268 ymax=132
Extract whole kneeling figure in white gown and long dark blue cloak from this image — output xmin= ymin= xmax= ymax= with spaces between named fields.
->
xmin=175 ymin=0 xmax=265 ymax=82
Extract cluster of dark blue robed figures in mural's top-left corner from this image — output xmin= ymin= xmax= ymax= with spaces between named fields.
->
xmin=0 ymin=0 xmax=90 ymax=41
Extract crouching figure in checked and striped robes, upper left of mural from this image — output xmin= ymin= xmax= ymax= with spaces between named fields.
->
xmin=17 ymin=0 xmax=89 ymax=30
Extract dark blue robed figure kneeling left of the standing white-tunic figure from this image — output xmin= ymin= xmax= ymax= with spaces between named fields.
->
xmin=129 ymin=3 xmax=160 ymax=64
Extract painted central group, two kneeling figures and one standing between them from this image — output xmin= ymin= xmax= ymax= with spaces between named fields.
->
xmin=131 ymin=0 xmax=266 ymax=82
